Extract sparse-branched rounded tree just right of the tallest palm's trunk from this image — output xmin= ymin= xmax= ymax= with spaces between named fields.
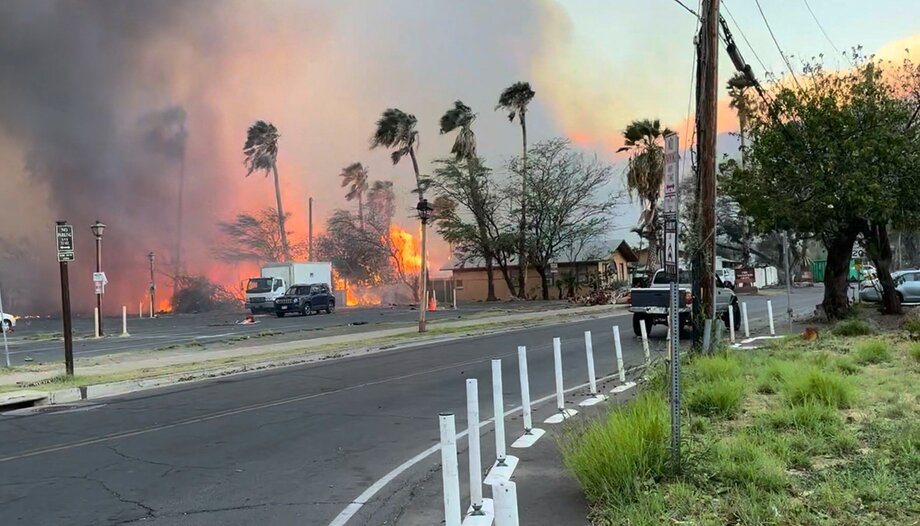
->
xmin=511 ymin=139 xmax=619 ymax=300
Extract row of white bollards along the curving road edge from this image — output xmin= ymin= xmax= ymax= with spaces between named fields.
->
xmin=440 ymin=324 xmax=648 ymax=526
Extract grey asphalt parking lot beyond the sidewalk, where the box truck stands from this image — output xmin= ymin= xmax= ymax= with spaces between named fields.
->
xmin=0 ymin=302 xmax=568 ymax=365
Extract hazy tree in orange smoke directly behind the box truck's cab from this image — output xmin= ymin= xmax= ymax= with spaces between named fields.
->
xmin=214 ymin=208 xmax=307 ymax=262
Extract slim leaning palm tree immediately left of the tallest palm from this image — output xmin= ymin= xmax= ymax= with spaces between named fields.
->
xmin=441 ymin=100 xmax=498 ymax=301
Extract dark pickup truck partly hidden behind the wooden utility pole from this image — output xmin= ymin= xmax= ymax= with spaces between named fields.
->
xmin=629 ymin=270 xmax=741 ymax=336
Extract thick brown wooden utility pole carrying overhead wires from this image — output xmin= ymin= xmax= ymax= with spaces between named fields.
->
xmin=696 ymin=0 xmax=719 ymax=318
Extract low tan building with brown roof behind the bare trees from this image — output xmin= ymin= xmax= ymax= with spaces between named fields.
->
xmin=441 ymin=239 xmax=638 ymax=301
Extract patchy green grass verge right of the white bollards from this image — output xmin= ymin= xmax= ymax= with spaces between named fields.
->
xmin=561 ymin=327 xmax=920 ymax=526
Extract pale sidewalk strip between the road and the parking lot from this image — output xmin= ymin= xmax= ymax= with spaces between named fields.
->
xmin=0 ymin=305 xmax=625 ymax=387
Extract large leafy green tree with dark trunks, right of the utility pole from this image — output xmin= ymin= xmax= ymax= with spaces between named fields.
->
xmin=726 ymin=55 xmax=920 ymax=318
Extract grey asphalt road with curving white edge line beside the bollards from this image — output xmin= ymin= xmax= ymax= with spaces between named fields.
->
xmin=0 ymin=290 xmax=819 ymax=525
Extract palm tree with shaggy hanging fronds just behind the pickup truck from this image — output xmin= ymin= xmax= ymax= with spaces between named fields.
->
xmin=617 ymin=119 xmax=672 ymax=275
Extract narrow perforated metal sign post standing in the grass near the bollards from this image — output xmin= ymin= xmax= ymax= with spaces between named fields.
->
xmin=664 ymin=133 xmax=680 ymax=466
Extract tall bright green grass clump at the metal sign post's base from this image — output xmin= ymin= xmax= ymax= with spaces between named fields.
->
xmin=560 ymin=392 xmax=670 ymax=504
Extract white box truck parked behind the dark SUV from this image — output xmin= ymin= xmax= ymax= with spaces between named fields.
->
xmin=246 ymin=262 xmax=332 ymax=314
